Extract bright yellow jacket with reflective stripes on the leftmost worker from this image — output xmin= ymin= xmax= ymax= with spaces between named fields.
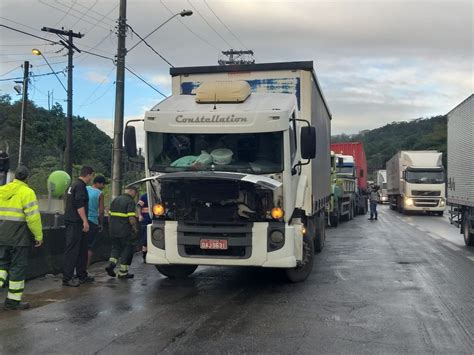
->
xmin=0 ymin=180 xmax=43 ymax=246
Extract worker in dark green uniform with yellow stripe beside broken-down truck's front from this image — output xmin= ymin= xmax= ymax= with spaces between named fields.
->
xmin=105 ymin=186 xmax=138 ymax=279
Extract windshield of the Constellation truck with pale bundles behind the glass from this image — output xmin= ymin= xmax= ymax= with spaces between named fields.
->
xmin=148 ymin=132 xmax=283 ymax=174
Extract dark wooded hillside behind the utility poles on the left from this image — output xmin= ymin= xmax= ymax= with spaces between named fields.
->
xmin=0 ymin=95 xmax=112 ymax=194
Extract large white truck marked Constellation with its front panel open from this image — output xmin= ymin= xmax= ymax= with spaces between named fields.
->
xmin=125 ymin=62 xmax=331 ymax=282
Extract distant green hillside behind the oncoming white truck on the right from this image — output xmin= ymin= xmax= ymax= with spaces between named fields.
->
xmin=331 ymin=116 xmax=447 ymax=174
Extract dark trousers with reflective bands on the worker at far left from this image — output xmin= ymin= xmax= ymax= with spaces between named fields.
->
xmin=0 ymin=246 xmax=29 ymax=302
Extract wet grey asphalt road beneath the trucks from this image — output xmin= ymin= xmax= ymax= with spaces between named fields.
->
xmin=0 ymin=206 xmax=474 ymax=354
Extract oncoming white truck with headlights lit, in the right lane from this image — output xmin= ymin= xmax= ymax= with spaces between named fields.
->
xmin=386 ymin=150 xmax=446 ymax=216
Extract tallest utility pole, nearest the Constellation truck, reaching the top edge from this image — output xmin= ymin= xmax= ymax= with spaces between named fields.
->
xmin=112 ymin=0 xmax=127 ymax=198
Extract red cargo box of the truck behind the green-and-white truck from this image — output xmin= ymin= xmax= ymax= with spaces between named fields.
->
xmin=331 ymin=142 xmax=368 ymax=214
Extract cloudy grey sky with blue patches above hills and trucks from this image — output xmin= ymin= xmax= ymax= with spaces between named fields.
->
xmin=0 ymin=0 xmax=474 ymax=139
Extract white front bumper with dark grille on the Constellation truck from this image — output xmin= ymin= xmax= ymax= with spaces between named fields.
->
xmin=146 ymin=221 xmax=303 ymax=268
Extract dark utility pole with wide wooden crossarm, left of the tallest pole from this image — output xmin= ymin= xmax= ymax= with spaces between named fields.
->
xmin=41 ymin=27 xmax=84 ymax=176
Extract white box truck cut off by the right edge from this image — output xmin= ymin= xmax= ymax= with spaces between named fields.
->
xmin=448 ymin=95 xmax=474 ymax=246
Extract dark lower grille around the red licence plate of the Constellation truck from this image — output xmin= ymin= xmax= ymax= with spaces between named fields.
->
xmin=178 ymin=222 xmax=253 ymax=259
